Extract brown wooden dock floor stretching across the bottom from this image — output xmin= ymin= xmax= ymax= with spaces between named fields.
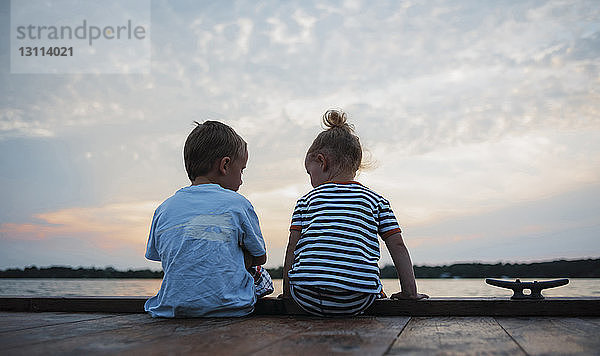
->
xmin=0 ymin=311 xmax=600 ymax=355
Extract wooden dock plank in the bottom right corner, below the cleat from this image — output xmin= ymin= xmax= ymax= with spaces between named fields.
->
xmin=497 ymin=317 xmax=600 ymax=355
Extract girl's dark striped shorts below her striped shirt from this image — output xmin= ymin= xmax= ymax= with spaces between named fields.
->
xmin=290 ymin=284 xmax=378 ymax=316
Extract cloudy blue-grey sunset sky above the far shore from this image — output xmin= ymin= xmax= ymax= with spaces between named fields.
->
xmin=0 ymin=0 xmax=600 ymax=269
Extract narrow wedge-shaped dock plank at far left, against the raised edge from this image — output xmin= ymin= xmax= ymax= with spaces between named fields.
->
xmin=0 ymin=312 xmax=116 ymax=339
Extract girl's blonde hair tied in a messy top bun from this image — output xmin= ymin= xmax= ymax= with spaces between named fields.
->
xmin=306 ymin=109 xmax=362 ymax=175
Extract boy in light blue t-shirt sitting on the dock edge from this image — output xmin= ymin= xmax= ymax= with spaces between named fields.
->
xmin=144 ymin=121 xmax=272 ymax=318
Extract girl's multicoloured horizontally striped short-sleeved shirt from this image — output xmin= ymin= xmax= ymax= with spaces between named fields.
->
xmin=288 ymin=181 xmax=400 ymax=293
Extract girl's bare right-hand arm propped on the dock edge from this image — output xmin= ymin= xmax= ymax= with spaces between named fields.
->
xmin=385 ymin=232 xmax=429 ymax=299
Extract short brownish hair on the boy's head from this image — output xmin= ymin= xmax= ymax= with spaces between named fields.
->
xmin=183 ymin=121 xmax=247 ymax=182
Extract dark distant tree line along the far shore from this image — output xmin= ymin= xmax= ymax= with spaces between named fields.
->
xmin=0 ymin=259 xmax=600 ymax=279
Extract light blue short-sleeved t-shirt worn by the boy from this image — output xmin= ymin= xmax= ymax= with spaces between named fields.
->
xmin=144 ymin=184 xmax=266 ymax=317
